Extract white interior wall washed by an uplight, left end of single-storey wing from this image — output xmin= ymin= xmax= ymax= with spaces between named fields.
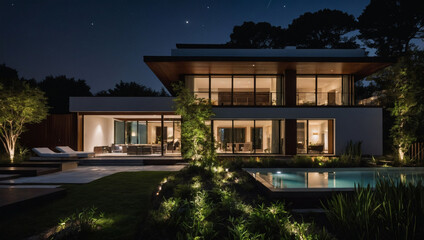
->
xmin=84 ymin=115 xmax=113 ymax=151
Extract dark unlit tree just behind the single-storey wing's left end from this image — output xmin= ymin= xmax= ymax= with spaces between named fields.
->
xmin=38 ymin=75 xmax=92 ymax=113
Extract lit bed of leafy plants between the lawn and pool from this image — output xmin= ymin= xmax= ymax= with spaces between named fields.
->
xmin=143 ymin=166 xmax=330 ymax=239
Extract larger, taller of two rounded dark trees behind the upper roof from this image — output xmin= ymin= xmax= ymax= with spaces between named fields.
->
xmin=286 ymin=9 xmax=358 ymax=48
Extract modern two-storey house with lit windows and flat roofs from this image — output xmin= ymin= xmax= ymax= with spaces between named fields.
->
xmin=70 ymin=44 xmax=395 ymax=156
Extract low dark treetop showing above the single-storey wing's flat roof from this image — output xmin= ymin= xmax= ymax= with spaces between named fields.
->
xmin=96 ymin=81 xmax=168 ymax=97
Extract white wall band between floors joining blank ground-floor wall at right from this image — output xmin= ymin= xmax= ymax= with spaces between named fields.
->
xmin=213 ymin=107 xmax=383 ymax=156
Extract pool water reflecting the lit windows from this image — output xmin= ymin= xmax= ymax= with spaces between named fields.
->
xmin=245 ymin=168 xmax=424 ymax=189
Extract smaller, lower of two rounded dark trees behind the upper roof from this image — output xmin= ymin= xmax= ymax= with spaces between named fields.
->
xmin=227 ymin=22 xmax=285 ymax=48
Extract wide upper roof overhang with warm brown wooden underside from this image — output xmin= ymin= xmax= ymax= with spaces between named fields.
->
xmin=144 ymin=56 xmax=396 ymax=92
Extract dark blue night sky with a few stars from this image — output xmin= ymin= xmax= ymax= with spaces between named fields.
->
xmin=0 ymin=0 xmax=369 ymax=93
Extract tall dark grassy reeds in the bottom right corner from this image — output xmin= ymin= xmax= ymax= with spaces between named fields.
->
xmin=325 ymin=179 xmax=424 ymax=239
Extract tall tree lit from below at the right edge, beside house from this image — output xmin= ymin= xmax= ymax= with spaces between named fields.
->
xmin=371 ymin=50 xmax=424 ymax=160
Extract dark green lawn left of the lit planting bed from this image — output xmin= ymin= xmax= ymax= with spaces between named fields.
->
xmin=0 ymin=172 xmax=171 ymax=239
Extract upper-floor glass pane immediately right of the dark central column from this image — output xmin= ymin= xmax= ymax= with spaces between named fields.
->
xmin=296 ymin=76 xmax=316 ymax=105
